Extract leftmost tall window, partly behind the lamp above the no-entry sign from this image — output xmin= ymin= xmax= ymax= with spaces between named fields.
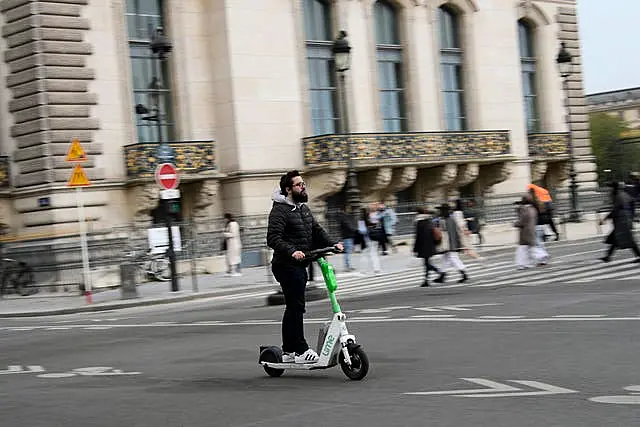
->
xmin=126 ymin=0 xmax=174 ymax=142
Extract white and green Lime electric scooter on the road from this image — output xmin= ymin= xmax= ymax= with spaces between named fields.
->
xmin=258 ymin=246 xmax=369 ymax=380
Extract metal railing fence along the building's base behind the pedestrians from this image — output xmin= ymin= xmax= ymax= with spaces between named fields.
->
xmin=2 ymin=186 xmax=609 ymax=288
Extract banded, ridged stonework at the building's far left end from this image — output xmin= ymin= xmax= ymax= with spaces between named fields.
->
xmin=0 ymin=0 xmax=101 ymax=187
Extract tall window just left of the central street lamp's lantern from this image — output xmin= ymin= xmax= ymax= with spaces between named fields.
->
xmin=304 ymin=0 xmax=338 ymax=135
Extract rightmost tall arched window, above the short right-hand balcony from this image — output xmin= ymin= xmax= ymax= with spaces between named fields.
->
xmin=518 ymin=21 xmax=540 ymax=133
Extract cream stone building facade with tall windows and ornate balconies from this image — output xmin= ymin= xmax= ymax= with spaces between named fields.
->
xmin=0 ymin=0 xmax=595 ymax=234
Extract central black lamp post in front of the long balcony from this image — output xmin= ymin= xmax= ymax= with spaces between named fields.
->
xmin=332 ymin=30 xmax=360 ymax=222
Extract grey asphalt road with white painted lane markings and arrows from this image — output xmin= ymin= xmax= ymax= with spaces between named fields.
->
xmin=0 ymin=245 xmax=640 ymax=427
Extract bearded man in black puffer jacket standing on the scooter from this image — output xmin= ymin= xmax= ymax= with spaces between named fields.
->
xmin=267 ymin=170 xmax=344 ymax=363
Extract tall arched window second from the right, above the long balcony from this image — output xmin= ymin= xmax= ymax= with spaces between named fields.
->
xmin=438 ymin=6 xmax=467 ymax=130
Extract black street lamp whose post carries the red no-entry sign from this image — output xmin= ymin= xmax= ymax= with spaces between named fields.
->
xmin=135 ymin=27 xmax=180 ymax=292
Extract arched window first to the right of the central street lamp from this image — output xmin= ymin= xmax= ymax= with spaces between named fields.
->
xmin=374 ymin=0 xmax=407 ymax=132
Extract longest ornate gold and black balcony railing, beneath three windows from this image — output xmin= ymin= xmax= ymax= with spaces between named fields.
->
xmin=302 ymin=130 xmax=511 ymax=167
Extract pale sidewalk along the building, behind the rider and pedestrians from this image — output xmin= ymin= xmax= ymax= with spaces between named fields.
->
xmin=0 ymin=217 xmax=610 ymax=318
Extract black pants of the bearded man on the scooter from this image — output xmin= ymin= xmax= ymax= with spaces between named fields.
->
xmin=272 ymin=264 xmax=309 ymax=354
